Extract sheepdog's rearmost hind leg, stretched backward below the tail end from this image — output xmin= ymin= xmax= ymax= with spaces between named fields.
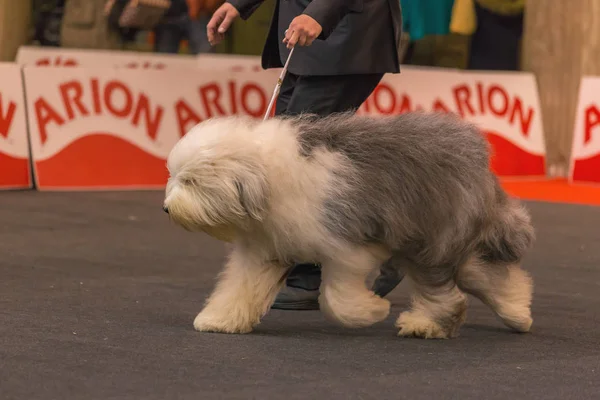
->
xmin=456 ymin=257 xmax=533 ymax=332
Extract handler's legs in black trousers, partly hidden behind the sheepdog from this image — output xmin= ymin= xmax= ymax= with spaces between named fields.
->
xmin=272 ymin=73 xmax=402 ymax=310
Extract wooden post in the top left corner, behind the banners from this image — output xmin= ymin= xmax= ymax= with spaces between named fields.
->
xmin=0 ymin=0 xmax=31 ymax=61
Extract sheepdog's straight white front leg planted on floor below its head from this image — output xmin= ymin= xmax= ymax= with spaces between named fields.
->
xmin=194 ymin=247 xmax=286 ymax=333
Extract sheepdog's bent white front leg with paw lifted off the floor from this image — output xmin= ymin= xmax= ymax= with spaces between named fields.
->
xmin=319 ymin=247 xmax=390 ymax=328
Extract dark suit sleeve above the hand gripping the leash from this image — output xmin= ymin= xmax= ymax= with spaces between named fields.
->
xmin=304 ymin=0 xmax=363 ymax=40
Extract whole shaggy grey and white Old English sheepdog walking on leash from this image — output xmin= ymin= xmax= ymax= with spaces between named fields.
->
xmin=163 ymin=113 xmax=534 ymax=338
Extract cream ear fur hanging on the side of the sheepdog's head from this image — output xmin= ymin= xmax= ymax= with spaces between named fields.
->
xmin=234 ymin=171 xmax=269 ymax=221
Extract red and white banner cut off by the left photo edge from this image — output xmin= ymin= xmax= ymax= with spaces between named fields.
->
xmin=0 ymin=63 xmax=32 ymax=189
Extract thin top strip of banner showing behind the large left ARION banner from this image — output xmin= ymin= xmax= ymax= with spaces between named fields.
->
xmin=16 ymin=46 xmax=262 ymax=72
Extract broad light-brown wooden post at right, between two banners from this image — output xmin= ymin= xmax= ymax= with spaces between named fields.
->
xmin=523 ymin=0 xmax=600 ymax=176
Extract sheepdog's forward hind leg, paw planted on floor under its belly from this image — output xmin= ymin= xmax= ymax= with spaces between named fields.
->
xmin=396 ymin=263 xmax=467 ymax=339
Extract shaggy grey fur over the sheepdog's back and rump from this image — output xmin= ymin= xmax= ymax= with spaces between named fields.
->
xmin=292 ymin=113 xmax=533 ymax=266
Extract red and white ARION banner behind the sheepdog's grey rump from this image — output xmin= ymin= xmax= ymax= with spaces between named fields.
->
xmin=360 ymin=66 xmax=546 ymax=178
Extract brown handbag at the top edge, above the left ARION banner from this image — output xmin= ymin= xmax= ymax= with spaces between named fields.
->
xmin=104 ymin=0 xmax=171 ymax=29
